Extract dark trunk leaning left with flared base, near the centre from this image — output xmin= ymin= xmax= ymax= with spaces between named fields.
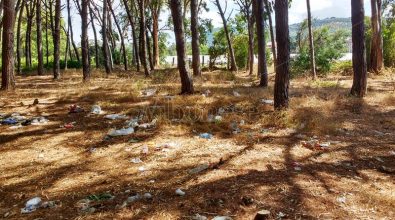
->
xmin=169 ymin=0 xmax=194 ymax=94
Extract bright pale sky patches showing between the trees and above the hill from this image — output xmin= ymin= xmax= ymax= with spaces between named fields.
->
xmin=68 ymin=0 xmax=371 ymax=42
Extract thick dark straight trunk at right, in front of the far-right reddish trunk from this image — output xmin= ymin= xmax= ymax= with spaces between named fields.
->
xmin=351 ymin=0 xmax=367 ymax=97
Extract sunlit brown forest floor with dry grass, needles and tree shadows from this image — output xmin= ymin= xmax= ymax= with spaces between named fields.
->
xmin=0 ymin=71 xmax=395 ymax=219
